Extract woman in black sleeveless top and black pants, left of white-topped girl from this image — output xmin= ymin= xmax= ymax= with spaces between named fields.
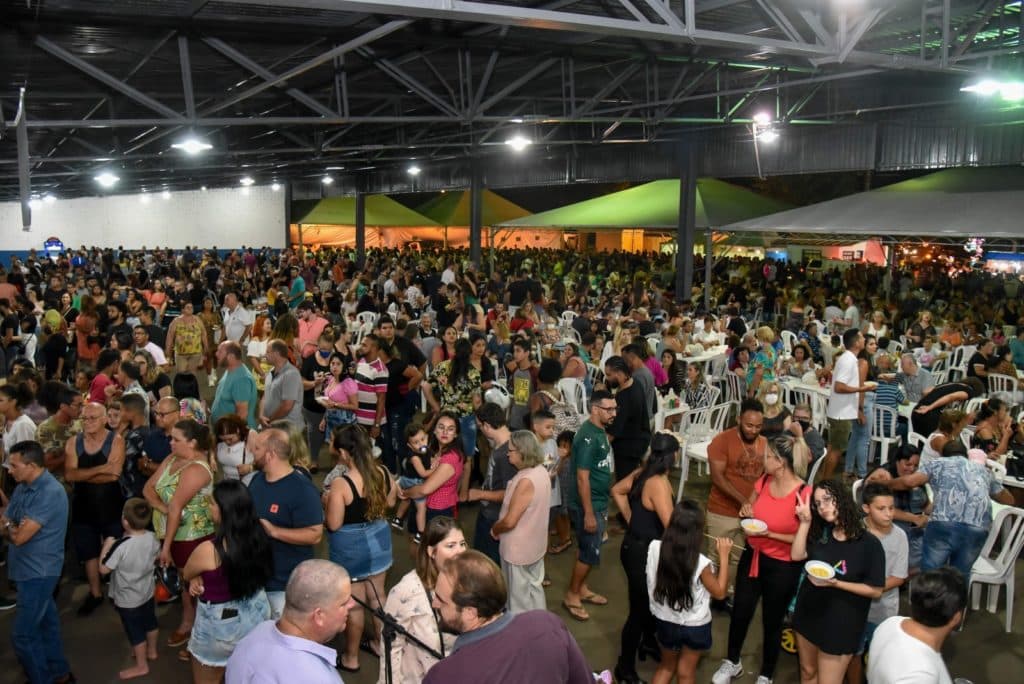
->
xmin=611 ymin=432 xmax=679 ymax=684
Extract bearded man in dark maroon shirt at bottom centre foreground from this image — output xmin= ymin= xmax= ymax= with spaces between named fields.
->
xmin=421 ymin=551 xmax=594 ymax=684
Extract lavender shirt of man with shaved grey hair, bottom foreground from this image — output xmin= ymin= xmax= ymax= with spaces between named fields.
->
xmin=226 ymin=619 xmax=341 ymax=684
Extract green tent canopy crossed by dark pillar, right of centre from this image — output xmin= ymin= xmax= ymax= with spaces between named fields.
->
xmin=501 ymin=178 xmax=790 ymax=230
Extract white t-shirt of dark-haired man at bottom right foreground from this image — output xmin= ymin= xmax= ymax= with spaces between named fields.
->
xmin=867 ymin=615 xmax=952 ymax=684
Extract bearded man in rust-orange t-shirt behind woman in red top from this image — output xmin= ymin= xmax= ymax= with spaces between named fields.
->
xmin=706 ymin=399 xmax=768 ymax=606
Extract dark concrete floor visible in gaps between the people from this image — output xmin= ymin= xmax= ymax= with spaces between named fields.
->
xmin=0 ymin=477 xmax=1024 ymax=684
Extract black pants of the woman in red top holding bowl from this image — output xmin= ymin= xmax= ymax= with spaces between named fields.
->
xmin=726 ymin=548 xmax=803 ymax=679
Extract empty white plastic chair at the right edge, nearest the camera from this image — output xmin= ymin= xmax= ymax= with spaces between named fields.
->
xmin=969 ymin=506 xmax=1024 ymax=633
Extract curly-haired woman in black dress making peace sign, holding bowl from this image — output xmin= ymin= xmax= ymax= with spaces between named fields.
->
xmin=792 ymin=480 xmax=886 ymax=684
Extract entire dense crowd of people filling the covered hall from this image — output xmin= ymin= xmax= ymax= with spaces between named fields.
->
xmin=0 ymin=241 xmax=1024 ymax=684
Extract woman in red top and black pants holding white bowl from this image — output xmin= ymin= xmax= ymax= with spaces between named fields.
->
xmin=712 ymin=433 xmax=810 ymax=682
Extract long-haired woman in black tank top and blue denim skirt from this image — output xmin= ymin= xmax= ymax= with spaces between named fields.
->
xmin=324 ymin=425 xmax=397 ymax=672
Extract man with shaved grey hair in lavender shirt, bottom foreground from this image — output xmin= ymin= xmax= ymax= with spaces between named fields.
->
xmin=226 ymin=559 xmax=355 ymax=684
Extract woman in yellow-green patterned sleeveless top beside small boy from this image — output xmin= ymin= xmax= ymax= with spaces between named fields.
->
xmin=142 ymin=418 xmax=214 ymax=657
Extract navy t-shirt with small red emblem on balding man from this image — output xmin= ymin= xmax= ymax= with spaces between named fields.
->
xmin=249 ymin=470 xmax=324 ymax=589
